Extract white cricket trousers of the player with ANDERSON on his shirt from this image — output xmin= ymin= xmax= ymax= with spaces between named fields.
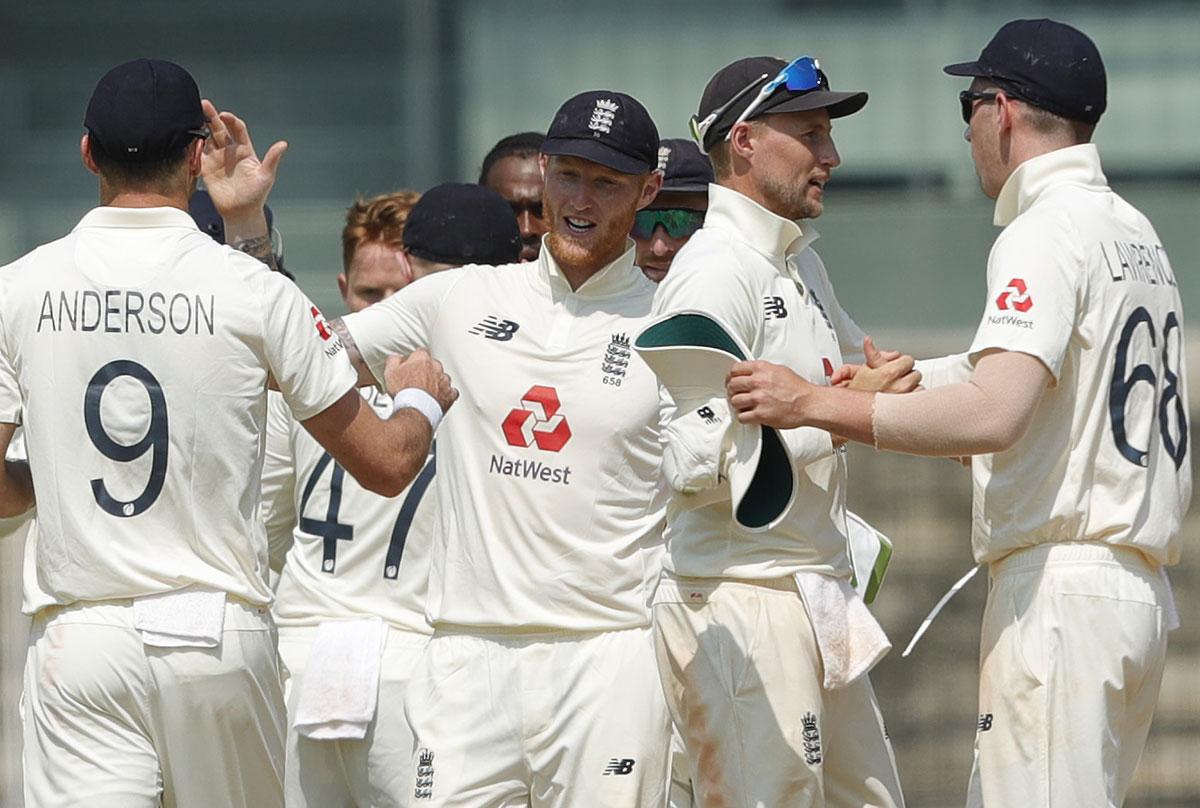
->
xmin=22 ymin=598 xmax=284 ymax=808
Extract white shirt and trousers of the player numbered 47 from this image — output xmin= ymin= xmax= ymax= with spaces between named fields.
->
xmin=263 ymin=388 xmax=434 ymax=808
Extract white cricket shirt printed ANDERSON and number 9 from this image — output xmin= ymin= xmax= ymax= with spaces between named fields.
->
xmin=0 ymin=208 xmax=354 ymax=604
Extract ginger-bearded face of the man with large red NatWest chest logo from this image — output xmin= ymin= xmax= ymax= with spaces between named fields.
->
xmin=541 ymin=155 xmax=649 ymax=280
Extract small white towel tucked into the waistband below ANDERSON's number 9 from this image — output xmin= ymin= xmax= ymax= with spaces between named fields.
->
xmin=133 ymin=586 xmax=226 ymax=648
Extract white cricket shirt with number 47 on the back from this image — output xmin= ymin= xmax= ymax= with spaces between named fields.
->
xmin=263 ymin=388 xmax=436 ymax=634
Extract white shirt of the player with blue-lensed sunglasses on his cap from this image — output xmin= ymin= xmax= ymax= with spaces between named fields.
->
xmin=654 ymin=185 xmax=863 ymax=579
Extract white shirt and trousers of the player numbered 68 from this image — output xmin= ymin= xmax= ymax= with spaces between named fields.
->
xmin=970 ymin=144 xmax=1192 ymax=808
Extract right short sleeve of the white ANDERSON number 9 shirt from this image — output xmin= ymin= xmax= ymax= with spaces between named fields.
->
xmin=260 ymin=273 xmax=358 ymax=420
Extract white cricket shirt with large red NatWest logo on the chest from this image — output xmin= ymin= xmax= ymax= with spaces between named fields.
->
xmin=346 ymin=241 xmax=664 ymax=630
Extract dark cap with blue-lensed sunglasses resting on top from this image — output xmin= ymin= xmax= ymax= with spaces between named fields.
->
xmin=692 ymin=56 xmax=866 ymax=151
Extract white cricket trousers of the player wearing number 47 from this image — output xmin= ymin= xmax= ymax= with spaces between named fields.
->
xmin=280 ymin=626 xmax=428 ymax=808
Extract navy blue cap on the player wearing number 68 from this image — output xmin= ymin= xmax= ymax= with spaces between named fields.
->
xmin=943 ymin=19 xmax=1108 ymax=124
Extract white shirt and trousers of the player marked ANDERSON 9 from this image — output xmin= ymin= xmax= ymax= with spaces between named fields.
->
xmin=0 ymin=208 xmax=354 ymax=808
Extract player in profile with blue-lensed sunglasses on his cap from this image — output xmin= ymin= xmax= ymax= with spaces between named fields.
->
xmin=636 ymin=56 xmax=917 ymax=808
